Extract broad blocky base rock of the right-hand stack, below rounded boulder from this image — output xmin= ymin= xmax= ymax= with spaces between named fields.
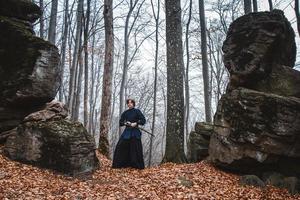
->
xmin=209 ymin=88 xmax=300 ymax=175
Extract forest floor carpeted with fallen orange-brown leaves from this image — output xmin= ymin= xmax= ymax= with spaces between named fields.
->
xmin=0 ymin=145 xmax=300 ymax=200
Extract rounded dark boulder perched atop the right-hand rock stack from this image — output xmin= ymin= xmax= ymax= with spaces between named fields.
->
xmin=223 ymin=10 xmax=299 ymax=92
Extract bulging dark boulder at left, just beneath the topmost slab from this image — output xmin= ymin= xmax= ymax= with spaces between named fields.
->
xmin=0 ymin=16 xmax=59 ymax=106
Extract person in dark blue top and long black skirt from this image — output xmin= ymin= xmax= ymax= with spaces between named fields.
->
xmin=112 ymin=99 xmax=146 ymax=169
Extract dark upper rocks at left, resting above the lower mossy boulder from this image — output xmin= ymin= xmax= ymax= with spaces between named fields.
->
xmin=0 ymin=0 xmax=60 ymax=140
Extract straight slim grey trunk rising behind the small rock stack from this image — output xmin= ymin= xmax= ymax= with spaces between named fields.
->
xmin=199 ymin=0 xmax=212 ymax=122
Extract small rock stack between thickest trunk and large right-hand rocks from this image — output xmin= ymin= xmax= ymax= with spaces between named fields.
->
xmin=188 ymin=122 xmax=213 ymax=162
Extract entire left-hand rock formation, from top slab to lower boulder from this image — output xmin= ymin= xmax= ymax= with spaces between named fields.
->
xmin=0 ymin=0 xmax=98 ymax=175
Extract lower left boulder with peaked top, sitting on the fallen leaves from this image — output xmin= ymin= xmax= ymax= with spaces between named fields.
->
xmin=4 ymin=102 xmax=98 ymax=175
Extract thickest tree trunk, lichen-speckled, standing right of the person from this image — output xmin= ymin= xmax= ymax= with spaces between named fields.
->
xmin=163 ymin=0 xmax=187 ymax=163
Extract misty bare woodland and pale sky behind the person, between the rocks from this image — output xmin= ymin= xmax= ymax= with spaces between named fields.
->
xmin=35 ymin=0 xmax=300 ymax=165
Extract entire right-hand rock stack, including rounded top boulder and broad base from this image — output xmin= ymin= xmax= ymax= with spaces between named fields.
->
xmin=209 ymin=10 xmax=300 ymax=180
